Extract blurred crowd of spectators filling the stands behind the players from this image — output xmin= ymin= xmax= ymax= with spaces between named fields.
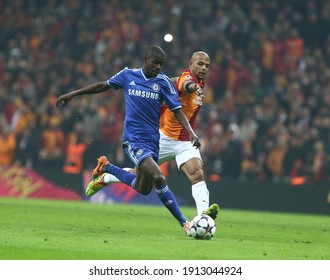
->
xmin=0 ymin=0 xmax=330 ymax=184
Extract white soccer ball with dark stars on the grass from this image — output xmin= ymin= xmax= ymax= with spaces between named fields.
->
xmin=190 ymin=214 xmax=216 ymax=240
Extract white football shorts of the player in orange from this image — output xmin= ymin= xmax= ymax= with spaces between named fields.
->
xmin=159 ymin=131 xmax=203 ymax=170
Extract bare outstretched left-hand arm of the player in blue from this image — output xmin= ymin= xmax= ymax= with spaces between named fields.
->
xmin=56 ymin=81 xmax=111 ymax=107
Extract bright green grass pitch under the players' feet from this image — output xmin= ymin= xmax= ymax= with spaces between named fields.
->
xmin=0 ymin=198 xmax=330 ymax=260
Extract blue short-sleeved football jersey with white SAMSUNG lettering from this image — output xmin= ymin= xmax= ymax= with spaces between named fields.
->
xmin=107 ymin=67 xmax=182 ymax=144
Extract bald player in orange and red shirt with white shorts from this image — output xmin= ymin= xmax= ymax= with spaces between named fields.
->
xmin=159 ymin=51 xmax=219 ymax=219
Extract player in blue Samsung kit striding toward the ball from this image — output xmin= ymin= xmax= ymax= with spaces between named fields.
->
xmin=56 ymin=45 xmax=200 ymax=235
